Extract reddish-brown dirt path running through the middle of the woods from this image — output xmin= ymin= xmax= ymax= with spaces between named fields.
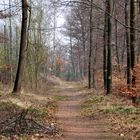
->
xmin=56 ymin=85 xmax=121 ymax=140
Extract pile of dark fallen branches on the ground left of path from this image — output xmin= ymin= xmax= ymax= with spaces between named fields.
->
xmin=0 ymin=109 xmax=56 ymax=135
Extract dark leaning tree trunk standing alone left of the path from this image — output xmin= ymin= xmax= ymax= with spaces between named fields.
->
xmin=13 ymin=0 xmax=28 ymax=93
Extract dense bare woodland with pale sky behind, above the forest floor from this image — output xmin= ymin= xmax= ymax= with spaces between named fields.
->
xmin=0 ymin=0 xmax=140 ymax=102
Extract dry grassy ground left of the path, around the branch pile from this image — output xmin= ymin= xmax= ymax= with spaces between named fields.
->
xmin=0 ymin=93 xmax=57 ymax=140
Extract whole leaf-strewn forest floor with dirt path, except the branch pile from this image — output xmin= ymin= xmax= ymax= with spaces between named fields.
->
xmin=0 ymin=81 xmax=140 ymax=140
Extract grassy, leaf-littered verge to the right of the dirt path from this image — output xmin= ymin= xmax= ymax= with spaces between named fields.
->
xmin=81 ymin=95 xmax=140 ymax=140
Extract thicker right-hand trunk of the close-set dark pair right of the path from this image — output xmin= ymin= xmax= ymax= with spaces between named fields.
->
xmin=106 ymin=0 xmax=112 ymax=94
